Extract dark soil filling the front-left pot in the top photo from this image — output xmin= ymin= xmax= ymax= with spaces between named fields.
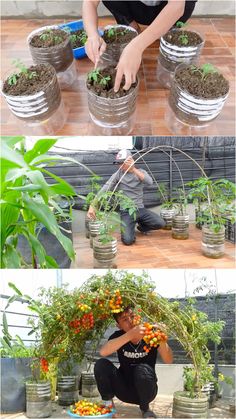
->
xmin=3 ymin=64 xmax=55 ymax=96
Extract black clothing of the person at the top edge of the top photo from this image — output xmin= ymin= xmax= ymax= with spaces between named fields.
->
xmin=103 ymin=0 xmax=197 ymax=25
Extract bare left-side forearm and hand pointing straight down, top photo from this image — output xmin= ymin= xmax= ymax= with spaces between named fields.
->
xmin=82 ymin=0 xmax=106 ymax=66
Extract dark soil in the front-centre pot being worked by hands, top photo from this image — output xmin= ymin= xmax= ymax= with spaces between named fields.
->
xmin=87 ymin=66 xmax=137 ymax=99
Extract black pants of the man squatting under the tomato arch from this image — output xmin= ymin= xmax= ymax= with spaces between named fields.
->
xmin=94 ymin=358 xmax=158 ymax=411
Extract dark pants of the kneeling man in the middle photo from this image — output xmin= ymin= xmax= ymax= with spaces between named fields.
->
xmin=120 ymin=208 xmax=166 ymax=246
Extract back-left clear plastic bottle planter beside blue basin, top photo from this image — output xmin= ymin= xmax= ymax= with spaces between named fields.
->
xmin=27 ymin=25 xmax=77 ymax=89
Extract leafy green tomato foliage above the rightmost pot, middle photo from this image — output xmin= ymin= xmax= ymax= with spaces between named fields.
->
xmin=186 ymin=177 xmax=236 ymax=232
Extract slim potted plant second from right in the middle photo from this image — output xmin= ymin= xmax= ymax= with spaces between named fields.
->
xmin=172 ymin=188 xmax=189 ymax=240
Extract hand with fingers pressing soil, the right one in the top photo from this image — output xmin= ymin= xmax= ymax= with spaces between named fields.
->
xmin=114 ymin=38 xmax=142 ymax=92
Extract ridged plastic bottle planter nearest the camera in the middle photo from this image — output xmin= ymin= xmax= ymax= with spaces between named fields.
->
xmin=93 ymin=236 xmax=117 ymax=269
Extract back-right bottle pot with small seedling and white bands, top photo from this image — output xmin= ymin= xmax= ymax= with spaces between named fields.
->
xmin=157 ymin=21 xmax=204 ymax=88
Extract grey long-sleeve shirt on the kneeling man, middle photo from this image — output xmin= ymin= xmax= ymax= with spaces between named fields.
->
xmin=98 ymin=169 xmax=153 ymax=208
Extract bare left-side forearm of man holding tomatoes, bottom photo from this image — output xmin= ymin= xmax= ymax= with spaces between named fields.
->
xmin=99 ymin=325 xmax=146 ymax=356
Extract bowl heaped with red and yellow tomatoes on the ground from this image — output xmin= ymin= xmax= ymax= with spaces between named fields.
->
xmin=67 ymin=400 xmax=115 ymax=418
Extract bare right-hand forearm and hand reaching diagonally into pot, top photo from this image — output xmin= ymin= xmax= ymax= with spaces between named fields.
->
xmin=114 ymin=0 xmax=188 ymax=92
